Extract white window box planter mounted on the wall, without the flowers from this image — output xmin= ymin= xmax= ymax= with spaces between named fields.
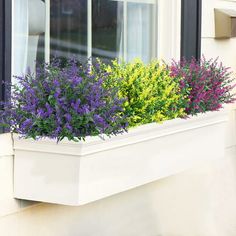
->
xmin=14 ymin=111 xmax=227 ymax=205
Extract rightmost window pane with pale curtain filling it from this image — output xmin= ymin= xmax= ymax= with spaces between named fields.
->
xmin=127 ymin=2 xmax=155 ymax=62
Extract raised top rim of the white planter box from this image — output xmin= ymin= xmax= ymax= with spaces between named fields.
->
xmin=13 ymin=110 xmax=228 ymax=156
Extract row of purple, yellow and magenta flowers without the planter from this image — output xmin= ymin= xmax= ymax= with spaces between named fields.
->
xmin=0 ymin=58 xmax=235 ymax=141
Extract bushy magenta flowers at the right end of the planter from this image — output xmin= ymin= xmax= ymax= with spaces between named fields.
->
xmin=170 ymin=57 xmax=235 ymax=115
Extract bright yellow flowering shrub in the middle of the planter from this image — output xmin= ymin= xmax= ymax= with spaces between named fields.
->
xmin=103 ymin=59 xmax=186 ymax=127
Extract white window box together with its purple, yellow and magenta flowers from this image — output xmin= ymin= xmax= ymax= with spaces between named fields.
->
xmin=7 ymin=56 xmax=235 ymax=206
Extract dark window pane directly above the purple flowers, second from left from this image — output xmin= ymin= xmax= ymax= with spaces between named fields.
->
xmin=50 ymin=0 xmax=87 ymax=61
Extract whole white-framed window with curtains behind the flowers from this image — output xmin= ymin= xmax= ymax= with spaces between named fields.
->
xmin=13 ymin=0 xmax=157 ymax=74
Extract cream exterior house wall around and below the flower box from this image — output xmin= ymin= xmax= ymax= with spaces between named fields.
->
xmin=0 ymin=0 xmax=236 ymax=236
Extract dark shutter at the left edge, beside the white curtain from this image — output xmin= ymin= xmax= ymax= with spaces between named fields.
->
xmin=0 ymin=0 xmax=11 ymax=132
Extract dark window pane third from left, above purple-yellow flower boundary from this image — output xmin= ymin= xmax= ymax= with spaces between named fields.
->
xmin=92 ymin=0 xmax=124 ymax=60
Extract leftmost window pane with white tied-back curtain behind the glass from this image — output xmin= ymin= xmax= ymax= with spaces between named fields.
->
xmin=12 ymin=0 xmax=46 ymax=75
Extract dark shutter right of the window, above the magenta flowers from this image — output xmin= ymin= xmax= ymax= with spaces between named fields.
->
xmin=181 ymin=0 xmax=202 ymax=60
